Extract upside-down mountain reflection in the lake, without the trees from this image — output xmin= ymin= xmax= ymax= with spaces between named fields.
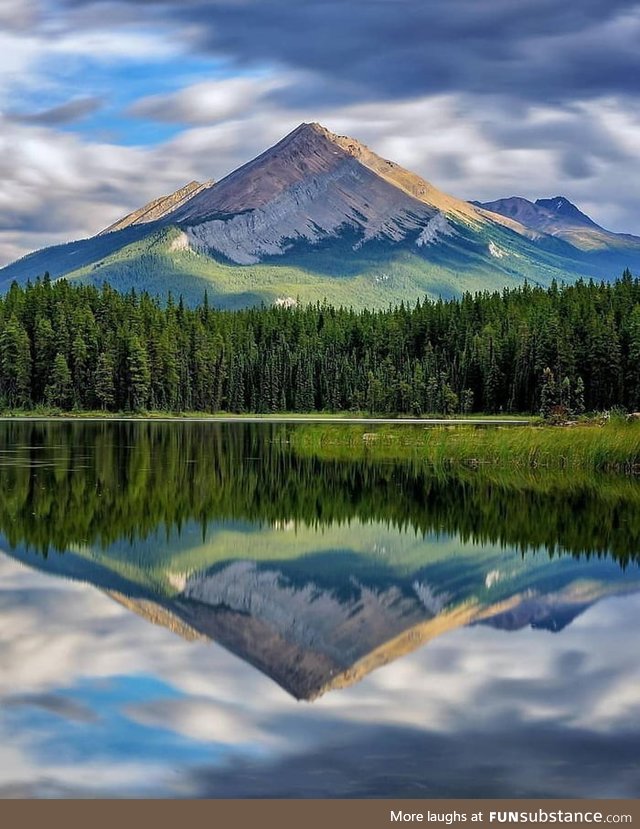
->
xmin=0 ymin=525 xmax=640 ymax=700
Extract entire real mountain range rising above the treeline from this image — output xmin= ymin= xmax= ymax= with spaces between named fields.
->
xmin=0 ymin=124 xmax=640 ymax=307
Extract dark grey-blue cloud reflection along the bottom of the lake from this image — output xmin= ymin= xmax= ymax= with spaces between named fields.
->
xmin=191 ymin=716 xmax=640 ymax=798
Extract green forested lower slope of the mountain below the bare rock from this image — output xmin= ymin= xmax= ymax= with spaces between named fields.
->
xmin=55 ymin=227 xmax=600 ymax=308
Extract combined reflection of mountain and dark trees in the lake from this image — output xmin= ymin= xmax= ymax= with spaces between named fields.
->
xmin=0 ymin=423 xmax=640 ymax=699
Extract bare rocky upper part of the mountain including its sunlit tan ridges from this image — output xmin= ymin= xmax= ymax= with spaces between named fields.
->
xmin=95 ymin=123 xmax=544 ymax=265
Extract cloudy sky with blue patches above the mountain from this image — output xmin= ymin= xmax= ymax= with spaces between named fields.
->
xmin=0 ymin=0 xmax=640 ymax=265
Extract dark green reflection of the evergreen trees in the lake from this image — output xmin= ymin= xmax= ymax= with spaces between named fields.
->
xmin=0 ymin=422 xmax=640 ymax=563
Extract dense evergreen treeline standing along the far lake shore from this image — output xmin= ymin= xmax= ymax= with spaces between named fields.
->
xmin=0 ymin=271 xmax=640 ymax=415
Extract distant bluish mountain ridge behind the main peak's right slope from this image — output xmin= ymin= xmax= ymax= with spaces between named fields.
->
xmin=472 ymin=196 xmax=640 ymax=254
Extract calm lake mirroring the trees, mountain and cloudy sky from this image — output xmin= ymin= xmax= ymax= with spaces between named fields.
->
xmin=0 ymin=421 xmax=640 ymax=798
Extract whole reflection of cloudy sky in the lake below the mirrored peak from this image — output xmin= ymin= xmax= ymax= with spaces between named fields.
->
xmin=0 ymin=558 xmax=640 ymax=796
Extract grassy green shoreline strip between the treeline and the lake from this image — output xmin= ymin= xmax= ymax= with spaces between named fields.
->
xmin=0 ymin=410 xmax=640 ymax=468
